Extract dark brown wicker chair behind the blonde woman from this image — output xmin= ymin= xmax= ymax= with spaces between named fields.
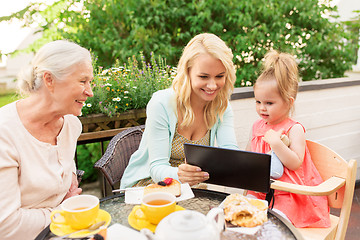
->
xmin=94 ymin=125 xmax=144 ymax=196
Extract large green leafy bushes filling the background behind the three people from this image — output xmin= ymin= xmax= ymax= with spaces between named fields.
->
xmin=0 ymin=0 xmax=355 ymax=87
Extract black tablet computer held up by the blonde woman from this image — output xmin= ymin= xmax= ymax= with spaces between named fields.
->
xmin=184 ymin=143 xmax=271 ymax=193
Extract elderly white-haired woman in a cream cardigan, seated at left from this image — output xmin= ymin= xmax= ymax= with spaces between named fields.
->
xmin=0 ymin=40 xmax=93 ymax=240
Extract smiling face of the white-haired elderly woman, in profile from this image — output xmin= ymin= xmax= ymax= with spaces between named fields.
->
xmin=54 ymin=62 xmax=94 ymax=116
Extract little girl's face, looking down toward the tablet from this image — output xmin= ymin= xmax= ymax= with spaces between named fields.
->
xmin=254 ymin=79 xmax=294 ymax=125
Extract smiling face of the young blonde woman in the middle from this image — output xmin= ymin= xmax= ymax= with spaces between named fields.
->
xmin=189 ymin=53 xmax=226 ymax=104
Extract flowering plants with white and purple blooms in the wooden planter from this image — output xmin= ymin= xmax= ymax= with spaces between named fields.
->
xmin=82 ymin=53 xmax=176 ymax=117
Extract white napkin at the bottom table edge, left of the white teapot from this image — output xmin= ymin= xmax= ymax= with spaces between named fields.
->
xmin=106 ymin=223 xmax=147 ymax=240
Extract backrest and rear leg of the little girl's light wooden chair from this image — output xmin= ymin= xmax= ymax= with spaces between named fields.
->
xmin=306 ymin=140 xmax=356 ymax=239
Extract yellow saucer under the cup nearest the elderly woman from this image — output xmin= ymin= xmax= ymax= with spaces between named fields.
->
xmin=50 ymin=209 xmax=111 ymax=238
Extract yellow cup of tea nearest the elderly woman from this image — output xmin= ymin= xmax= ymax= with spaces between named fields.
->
xmin=50 ymin=195 xmax=99 ymax=229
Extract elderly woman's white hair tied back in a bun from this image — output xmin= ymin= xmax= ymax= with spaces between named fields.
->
xmin=17 ymin=40 xmax=91 ymax=95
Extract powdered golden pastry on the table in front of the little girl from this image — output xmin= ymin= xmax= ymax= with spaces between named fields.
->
xmin=224 ymin=193 xmax=267 ymax=227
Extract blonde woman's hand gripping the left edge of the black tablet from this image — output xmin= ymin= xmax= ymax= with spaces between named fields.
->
xmin=178 ymin=164 xmax=209 ymax=186
